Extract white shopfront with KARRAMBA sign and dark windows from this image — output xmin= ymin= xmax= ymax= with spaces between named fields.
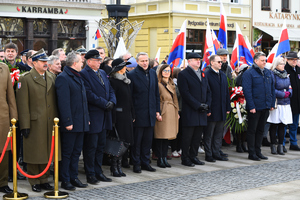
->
xmin=0 ymin=0 xmax=105 ymax=53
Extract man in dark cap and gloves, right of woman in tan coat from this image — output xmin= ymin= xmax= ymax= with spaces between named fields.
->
xmin=177 ymin=53 xmax=211 ymax=167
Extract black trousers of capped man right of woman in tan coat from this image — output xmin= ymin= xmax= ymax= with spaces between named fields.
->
xmin=181 ymin=126 xmax=203 ymax=160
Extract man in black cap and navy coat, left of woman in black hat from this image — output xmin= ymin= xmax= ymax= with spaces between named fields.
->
xmin=80 ymin=49 xmax=116 ymax=184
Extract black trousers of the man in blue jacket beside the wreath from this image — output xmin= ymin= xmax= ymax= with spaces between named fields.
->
xmin=247 ymin=109 xmax=269 ymax=156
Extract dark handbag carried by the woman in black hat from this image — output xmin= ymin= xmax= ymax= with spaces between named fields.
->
xmin=104 ymin=126 xmax=129 ymax=157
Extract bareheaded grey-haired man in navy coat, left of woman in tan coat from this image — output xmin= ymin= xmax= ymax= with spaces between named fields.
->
xmin=128 ymin=52 xmax=161 ymax=173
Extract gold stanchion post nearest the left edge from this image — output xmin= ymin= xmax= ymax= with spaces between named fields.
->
xmin=3 ymin=118 xmax=28 ymax=200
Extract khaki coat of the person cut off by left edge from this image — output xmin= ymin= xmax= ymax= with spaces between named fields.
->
xmin=0 ymin=63 xmax=18 ymax=154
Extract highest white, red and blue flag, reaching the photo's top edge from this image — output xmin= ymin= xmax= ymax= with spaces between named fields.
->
xmin=218 ymin=1 xmax=227 ymax=49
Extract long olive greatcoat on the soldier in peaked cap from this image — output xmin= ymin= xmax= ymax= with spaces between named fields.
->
xmin=17 ymin=68 xmax=60 ymax=164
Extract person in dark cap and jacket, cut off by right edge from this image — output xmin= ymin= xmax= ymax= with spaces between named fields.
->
xmin=285 ymin=52 xmax=300 ymax=151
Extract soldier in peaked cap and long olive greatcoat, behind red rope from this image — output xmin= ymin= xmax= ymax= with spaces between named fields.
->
xmin=17 ymin=49 xmax=60 ymax=192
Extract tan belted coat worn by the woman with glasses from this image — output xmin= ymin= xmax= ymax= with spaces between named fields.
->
xmin=154 ymin=83 xmax=179 ymax=140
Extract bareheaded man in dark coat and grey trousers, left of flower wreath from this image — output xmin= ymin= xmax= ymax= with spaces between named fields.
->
xmin=203 ymin=55 xmax=230 ymax=162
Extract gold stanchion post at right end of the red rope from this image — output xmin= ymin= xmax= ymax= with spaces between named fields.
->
xmin=44 ymin=118 xmax=69 ymax=199
